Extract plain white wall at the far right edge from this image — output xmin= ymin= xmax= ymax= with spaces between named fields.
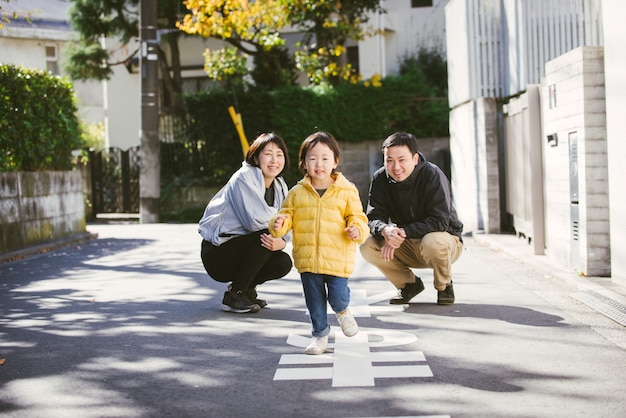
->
xmin=602 ymin=0 xmax=626 ymax=285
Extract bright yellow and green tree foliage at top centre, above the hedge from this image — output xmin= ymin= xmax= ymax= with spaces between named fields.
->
xmin=179 ymin=0 xmax=382 ymax=84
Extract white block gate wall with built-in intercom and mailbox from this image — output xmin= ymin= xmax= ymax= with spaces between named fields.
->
xmin=541 ymin=47 xmax=611 ymax=276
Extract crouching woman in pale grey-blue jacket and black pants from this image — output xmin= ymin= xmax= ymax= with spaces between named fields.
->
xmin=198 ymin=133 xmax=292 ymax=313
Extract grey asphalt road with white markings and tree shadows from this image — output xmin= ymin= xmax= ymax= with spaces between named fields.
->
xmin=0 ymin=224 xmax=626 ymax=418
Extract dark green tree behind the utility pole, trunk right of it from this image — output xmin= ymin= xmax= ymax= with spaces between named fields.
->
xmin=64 ymin=0 xmax=184 ymax=113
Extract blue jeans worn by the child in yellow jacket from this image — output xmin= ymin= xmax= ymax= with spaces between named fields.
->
xmin=300 ymin=273 xmax=350 ymax=337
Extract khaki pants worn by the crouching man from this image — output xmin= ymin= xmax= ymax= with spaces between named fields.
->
xmin=361 ymin=232 xmax=463 ymax=290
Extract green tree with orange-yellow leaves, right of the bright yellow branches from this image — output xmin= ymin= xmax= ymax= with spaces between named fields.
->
xmin=280 ymin=0 xmax=384 ymax=85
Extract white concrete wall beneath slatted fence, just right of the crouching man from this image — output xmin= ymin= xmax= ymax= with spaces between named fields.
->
xmin=450 ymin=98 xmax=500 ymax=233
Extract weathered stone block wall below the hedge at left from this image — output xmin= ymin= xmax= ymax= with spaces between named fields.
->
xmin=0 ymin=171 xmax=86 ymax=253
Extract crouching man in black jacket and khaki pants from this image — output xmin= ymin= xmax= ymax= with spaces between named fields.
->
xmin=361 ymin=132 xmax=463 ymax=305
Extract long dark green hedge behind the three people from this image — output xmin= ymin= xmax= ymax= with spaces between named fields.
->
xmin=180 ymin=69 xmax=449 ymax=185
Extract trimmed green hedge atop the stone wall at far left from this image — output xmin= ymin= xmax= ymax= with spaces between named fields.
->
xmin=0 ymin=65 xmax=81 ymax=172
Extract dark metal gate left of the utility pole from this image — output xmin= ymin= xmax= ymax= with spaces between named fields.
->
xmin=89 ymin=146 xmax=140 ymax=217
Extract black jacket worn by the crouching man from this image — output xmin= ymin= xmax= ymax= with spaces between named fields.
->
xmin=367 ymin=153 xmax=463 ymax=239
